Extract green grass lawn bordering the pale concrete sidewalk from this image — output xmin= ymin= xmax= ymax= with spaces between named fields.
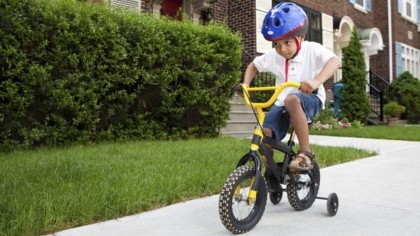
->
xmin=0 ymin=126 xmax=420 ymax=236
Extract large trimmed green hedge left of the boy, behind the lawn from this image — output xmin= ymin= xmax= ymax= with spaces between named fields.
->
xmin=0 ymin=0 xmax=241 ymax=150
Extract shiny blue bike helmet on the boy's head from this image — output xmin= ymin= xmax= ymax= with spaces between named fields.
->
xmin=261 ymin=2 xmax=308 ymax=41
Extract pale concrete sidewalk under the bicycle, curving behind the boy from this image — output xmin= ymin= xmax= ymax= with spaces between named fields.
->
xmin=52 ymin=136 xmax=420 ymax=236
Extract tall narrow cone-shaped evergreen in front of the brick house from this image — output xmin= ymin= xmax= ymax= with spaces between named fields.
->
xmin=340 ymin=28 xmax=370 ymax=123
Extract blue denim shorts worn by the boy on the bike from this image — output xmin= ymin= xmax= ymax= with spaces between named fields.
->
xmin=263 ymin=93 xmax=322 ymax=142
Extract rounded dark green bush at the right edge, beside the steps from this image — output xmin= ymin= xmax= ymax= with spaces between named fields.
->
xmin=386 ymin=71 xmax=420 ymax=123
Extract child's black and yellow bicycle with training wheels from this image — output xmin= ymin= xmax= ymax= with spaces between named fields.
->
xmin=219 ymin=82 xmax=338 ymax=234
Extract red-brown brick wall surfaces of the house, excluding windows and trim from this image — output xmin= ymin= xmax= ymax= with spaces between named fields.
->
xmin=141 ymin=0 xmax=420 ymax=82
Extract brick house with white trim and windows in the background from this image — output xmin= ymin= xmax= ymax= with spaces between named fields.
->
xmin=110 ymin=0 xmax=420 ymax=88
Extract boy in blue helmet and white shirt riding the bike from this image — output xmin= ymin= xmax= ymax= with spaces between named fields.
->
xmin=243 ymin=2 xmax=341 ymax=171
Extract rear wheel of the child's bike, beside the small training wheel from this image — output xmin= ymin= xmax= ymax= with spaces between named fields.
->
xmin=287 ymin=161 xmax=321 ymax=211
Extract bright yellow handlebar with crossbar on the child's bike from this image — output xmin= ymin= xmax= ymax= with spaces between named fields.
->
xmin=241 ymin=81 xmax=300 ymax=108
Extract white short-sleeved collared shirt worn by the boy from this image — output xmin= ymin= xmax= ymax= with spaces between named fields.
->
xmin=253 ymin=41 xmax=335 ymax=107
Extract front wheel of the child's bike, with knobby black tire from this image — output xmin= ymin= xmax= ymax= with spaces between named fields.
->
xmin=219 ymin=166 xmax=267 ymax=234
